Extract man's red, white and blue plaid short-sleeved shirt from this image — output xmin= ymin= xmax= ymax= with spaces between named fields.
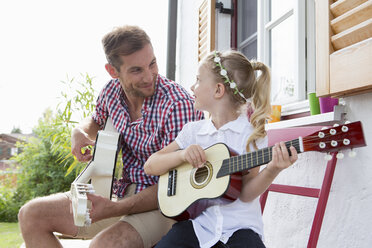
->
xmin=92 ymin=75 xmax=203 ymax=197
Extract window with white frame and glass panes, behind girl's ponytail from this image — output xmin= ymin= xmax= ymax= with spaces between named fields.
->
xmin=237 ymin=0 xmax=315 ymax=112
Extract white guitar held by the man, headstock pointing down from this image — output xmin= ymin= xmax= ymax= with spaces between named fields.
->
xmin=71 ymin=117 xmax=120 ymax=226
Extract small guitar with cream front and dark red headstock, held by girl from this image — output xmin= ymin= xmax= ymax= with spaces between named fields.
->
xmin=158 ymin=122 xmax=366 ymax=219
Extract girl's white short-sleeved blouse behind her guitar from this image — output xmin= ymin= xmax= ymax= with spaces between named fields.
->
xmin=176 ymin=115 xmax=267 ymax=248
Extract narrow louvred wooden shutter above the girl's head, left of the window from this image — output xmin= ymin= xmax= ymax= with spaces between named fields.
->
xmin=198 ymin=0 xmax=215 ymax=62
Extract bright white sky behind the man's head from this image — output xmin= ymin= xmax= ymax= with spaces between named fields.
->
xmin=0 ymin=0 xmax=168 ymax=134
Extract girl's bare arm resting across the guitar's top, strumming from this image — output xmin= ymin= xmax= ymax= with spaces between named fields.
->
xmin=144 ymin=141 xmax=206 ymax=176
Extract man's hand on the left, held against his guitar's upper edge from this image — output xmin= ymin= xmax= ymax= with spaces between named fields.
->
xmin=71 ymin=128 xmax=95 ymax=162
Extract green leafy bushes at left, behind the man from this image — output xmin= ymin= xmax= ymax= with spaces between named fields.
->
xmin=0 ymin=72 xmax=95 ymax=222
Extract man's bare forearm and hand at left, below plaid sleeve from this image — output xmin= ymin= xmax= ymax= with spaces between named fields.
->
xmin=71 ymin=118 xmax=99 ymax=162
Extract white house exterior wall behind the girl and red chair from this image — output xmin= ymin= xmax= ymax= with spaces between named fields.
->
xmin=176 ymin=0 xmax=372 ymax=248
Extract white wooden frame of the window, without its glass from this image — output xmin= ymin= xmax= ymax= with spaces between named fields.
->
xmin=257 ymin=0 xmax=315 ymax=115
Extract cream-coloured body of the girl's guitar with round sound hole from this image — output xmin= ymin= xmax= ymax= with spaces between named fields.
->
xmin=158 ymin=143 xmax=230 ymax=217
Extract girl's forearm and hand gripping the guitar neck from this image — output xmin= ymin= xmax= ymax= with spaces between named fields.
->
xmin=240 ymin=142 xmax=297 ymax=202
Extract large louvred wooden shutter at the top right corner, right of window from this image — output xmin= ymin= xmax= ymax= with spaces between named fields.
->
xmin=316 ymin=0 xmax=372 ymax=96
